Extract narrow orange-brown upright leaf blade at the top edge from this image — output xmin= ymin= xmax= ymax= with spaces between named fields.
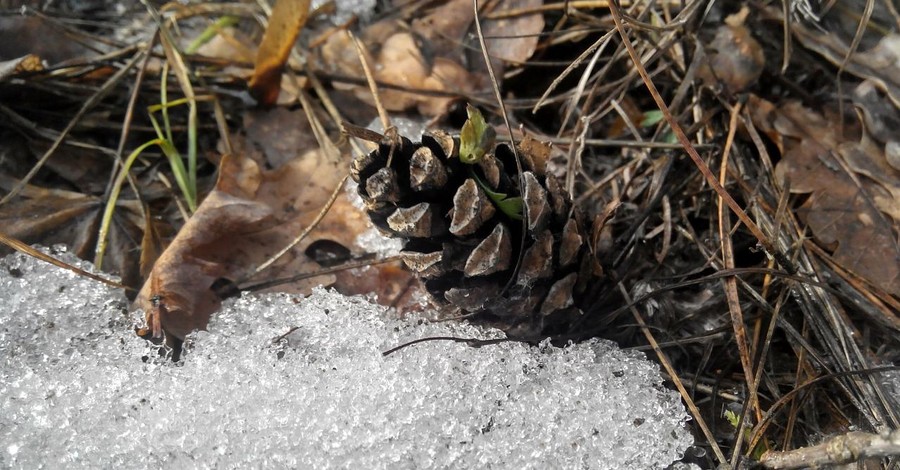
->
xmin=250 ymin=0 xmax=309 ymax=106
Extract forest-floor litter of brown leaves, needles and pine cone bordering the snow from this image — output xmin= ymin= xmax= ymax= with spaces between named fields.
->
xmin=0 ymin=0 xmax=900 ymax=468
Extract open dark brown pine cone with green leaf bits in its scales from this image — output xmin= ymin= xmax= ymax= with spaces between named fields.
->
xmin=351 ymin=119 xmax=599 ymax=337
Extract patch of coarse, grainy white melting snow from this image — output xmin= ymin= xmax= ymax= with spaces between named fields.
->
xmin=0 ymin=248 xmax=692 ymax=469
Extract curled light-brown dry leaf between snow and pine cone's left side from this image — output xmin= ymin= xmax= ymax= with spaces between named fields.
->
xmin=136 ymin=145 xmax=355 ymax=338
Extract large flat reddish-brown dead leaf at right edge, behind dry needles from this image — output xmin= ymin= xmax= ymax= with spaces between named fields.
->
xmin=748 ymin=97 xmax=900 ymax=295
